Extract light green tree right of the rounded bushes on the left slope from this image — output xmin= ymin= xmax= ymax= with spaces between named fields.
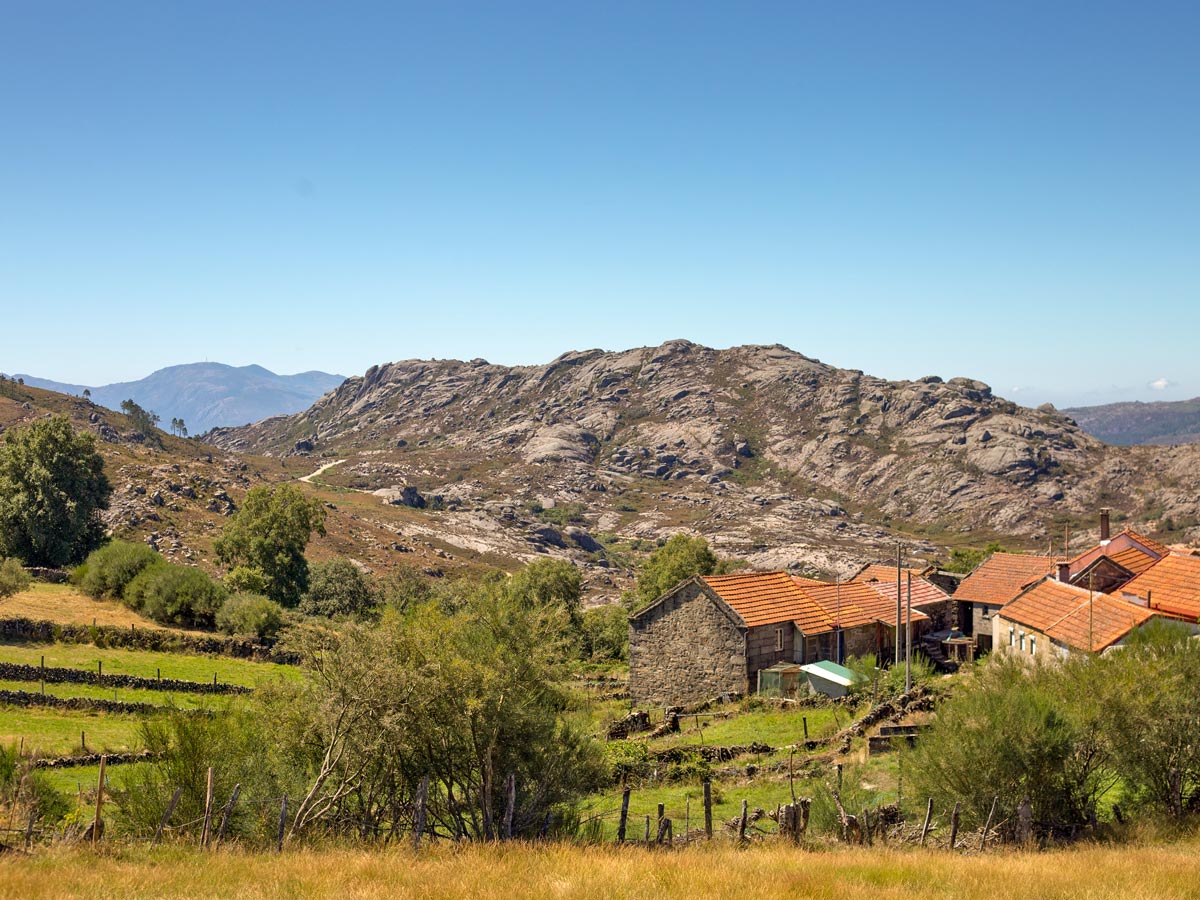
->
xmin=212 ymin=485 xmax=325 ymax=606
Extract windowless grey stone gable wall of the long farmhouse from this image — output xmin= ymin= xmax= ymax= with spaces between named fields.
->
xmin=629 ymin=583 xmax=748 ymax=704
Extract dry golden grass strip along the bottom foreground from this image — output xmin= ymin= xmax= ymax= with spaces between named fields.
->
xmin=0 ymin=839 xmax=1200 ymax=900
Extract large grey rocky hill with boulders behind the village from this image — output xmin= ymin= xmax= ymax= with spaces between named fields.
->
xmin=205 ymin=341 xmax=1200 ymax=595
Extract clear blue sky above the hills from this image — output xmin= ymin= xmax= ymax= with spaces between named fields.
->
xmin=0 ymin=0 xmax=1200 ymax=404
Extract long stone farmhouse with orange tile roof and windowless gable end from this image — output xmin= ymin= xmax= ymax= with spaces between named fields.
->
xmin=629 ymin=570 xmax=949 ymax=704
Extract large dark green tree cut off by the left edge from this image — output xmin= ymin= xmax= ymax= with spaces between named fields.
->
xmin=0 ymin=415 xmax=113 ymax=566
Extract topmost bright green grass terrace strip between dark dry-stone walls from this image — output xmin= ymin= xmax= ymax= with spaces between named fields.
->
xmin=0 ymin=643 xmax=301 ymax=688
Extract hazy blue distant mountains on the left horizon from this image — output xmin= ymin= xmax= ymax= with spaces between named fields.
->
xmin=18 ymin=362 xmax=346 ymax=434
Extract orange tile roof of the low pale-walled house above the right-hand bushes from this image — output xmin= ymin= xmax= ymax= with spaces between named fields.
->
xmin=996 ymin=578 xmax=1154 ymax=650
